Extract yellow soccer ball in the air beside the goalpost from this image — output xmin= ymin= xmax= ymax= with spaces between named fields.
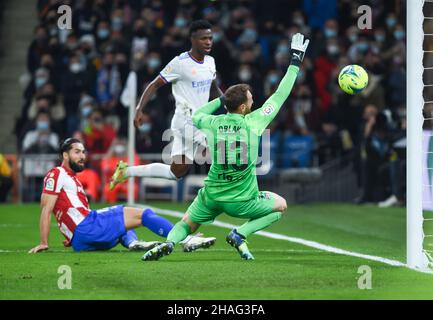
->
xmin=338 ymin=64 xmax=368 ymax=94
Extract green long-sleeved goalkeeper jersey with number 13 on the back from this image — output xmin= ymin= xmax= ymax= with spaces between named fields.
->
xmin=192 ymin=65 xmax=299 ymax=202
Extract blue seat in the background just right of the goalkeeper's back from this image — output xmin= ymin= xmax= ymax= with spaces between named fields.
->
xmin=281 ymin=134 xmax=313 ymax=168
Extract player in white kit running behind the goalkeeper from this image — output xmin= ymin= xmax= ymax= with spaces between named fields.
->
xmin=110 ymin=20 xmax=223 ymax=251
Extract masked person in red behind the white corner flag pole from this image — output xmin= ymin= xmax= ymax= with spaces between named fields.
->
xmin=101 ymin=138 xmax=140 ymax=203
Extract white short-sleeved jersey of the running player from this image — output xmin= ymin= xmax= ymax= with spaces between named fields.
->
xmin=159 ymin=52 xmax=216 ymax=116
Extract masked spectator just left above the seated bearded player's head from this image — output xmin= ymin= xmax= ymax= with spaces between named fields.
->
xmin=22 ymin=111 xmax=59 ymax=154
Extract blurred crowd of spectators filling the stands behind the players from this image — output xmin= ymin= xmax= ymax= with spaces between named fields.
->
xmin=16 ymin=0 xmax=406 ymax=202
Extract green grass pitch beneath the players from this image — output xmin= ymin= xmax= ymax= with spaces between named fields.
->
xmin=0 ymin=202 xmax=433 ymax=299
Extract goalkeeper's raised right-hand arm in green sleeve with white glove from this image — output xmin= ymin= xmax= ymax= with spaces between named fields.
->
xmin=247 ymin=33 xmax=310 ymax=134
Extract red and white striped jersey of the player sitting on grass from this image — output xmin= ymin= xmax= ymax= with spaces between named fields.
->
xmin=42 ymin=166 xmax=90 ymax=243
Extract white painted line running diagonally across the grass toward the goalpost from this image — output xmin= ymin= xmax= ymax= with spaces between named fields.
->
xmin=140 ymin=205 xmax=407 ymax=267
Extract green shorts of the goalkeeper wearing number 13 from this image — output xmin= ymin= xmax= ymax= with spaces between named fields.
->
xmin=186 ymin=188 xmax=275 ymax=224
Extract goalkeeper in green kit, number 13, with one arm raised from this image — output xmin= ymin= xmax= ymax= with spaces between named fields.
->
xmin=142 ymin=33 xmax=309 ymax=260
